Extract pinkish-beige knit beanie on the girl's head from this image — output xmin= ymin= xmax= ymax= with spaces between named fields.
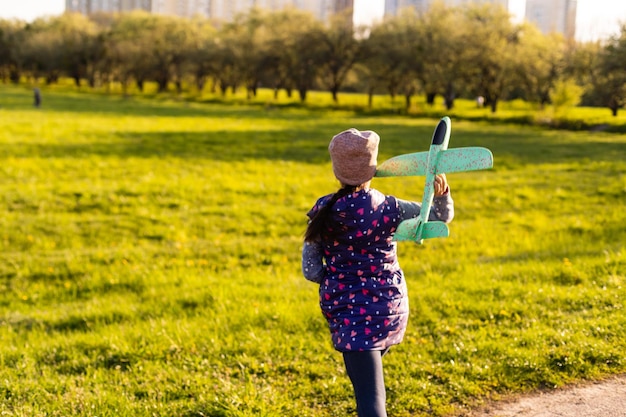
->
xmin=328 ymin=128 xmax=380 ymax=185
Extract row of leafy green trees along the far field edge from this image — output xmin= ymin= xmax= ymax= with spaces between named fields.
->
xmin=0 ymin=4 xmax=626 ymax=115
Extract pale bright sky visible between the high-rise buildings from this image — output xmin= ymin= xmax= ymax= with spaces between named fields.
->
xmin=0 ymin=0 xmax=626 ymax=41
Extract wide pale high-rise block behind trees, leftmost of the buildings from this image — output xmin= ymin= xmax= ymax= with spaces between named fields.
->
xmin=65 ymin=0 xmax=354 ymax=21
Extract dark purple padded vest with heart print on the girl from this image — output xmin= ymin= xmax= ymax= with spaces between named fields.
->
xmin=308 ymin=189 xmax=409 ymax=352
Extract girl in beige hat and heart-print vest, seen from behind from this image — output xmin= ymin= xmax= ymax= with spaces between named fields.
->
xmin=302 ymin=129 xmax=454 ymax=417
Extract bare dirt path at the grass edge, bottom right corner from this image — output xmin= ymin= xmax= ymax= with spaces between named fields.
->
xmin=468 ymin=375 xmax=626 ymax=417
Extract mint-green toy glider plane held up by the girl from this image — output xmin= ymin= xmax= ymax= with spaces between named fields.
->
xmin=376 ymin=117 xmax=493 ymax=243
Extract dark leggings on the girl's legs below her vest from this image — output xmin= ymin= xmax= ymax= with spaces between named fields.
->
xmin=343 ymin=350 xmax=387 ymax=417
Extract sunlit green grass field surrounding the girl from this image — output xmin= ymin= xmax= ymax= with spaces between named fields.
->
xmin=0 ymin=85 xmax=626 ymax=417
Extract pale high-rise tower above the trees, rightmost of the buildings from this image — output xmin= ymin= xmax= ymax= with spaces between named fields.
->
xmin=525 ymin=0 xmax=577 ymax=39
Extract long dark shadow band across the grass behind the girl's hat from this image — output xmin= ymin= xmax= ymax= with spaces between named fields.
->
xmin=2 ymin=122 xmax=626 ymax=169
